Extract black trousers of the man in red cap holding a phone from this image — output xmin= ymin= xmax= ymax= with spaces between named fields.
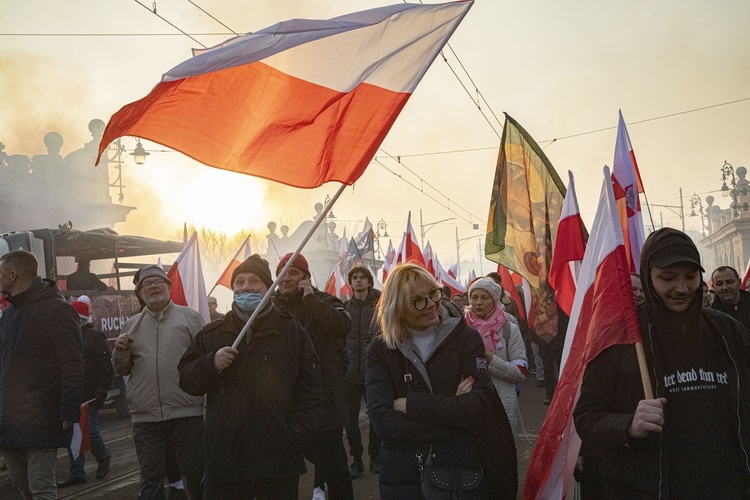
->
xmin=303 ymin=429 xmax=354 ymax=500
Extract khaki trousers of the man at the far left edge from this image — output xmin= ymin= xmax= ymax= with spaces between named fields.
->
xmin=3 ymin=448 xmax=57 ymax=500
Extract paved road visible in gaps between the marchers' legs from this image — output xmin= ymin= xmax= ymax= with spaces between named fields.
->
xmin=0 ymin=377 xmax=548 ymax=500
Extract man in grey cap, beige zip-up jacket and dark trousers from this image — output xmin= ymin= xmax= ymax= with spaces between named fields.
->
xmin=112 ymin=266 xmax=203 ymax=499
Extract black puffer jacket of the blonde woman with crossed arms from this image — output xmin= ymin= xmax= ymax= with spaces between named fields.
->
xmin=366 ymin=318 xmax=518 ymax=500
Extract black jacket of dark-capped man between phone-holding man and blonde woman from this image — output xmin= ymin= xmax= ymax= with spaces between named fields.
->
xmin=344 ymin=288 xmax=380 ymax=385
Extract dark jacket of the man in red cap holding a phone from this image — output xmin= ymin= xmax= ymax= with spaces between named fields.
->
xmin=273 ymin=290 xmax=351 ymax=431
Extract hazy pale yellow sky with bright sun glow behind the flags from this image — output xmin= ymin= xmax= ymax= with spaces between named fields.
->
xmin=0 ymin=0 xmax=750 ymax=273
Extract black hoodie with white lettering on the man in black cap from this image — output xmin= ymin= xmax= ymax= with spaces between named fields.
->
xmin=574 ymin=228 xmax=750 ymax=498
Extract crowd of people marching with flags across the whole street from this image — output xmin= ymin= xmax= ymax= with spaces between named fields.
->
xmin=0 ymin=225 xmax=750 ymax=500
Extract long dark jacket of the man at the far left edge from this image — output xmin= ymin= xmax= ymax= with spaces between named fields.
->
xmin=0 ymin=278 xmax=83 ymax=449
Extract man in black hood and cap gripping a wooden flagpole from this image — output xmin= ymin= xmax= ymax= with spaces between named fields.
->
xmin=574 ymin=228 xmax=750 ymax=498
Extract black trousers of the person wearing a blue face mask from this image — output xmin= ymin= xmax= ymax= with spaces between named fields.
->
xmin=203 ymin=476 xmax=299 ymax=500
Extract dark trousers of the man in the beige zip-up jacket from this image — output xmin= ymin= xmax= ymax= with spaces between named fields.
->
xmin=133 ymin=416 xmax=203 ymax=500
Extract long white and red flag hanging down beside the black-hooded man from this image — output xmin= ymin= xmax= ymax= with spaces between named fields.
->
xmin=523 ymin=167 xmax=641 ymax=499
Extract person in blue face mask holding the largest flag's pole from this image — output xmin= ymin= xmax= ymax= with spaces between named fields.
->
xmin=183 ymin=254 xmax=322 ymax=500
